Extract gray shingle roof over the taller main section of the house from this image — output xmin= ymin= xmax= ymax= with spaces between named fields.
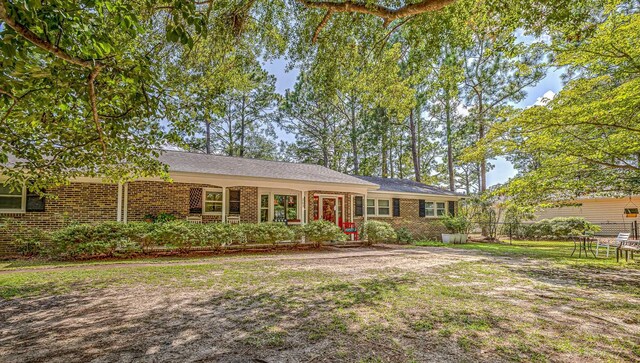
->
xmin=159 ymin=151 xmax=377 ymax=187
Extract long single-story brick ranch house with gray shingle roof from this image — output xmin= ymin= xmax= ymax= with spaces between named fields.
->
xmin=0 ymin=151 xmax=462 ymax=253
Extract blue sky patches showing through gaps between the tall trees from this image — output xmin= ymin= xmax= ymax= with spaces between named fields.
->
xmin=264 ymin=59 xmax=562 ymax=186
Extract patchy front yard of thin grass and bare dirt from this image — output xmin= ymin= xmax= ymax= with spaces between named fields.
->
xmin=0 ymin=248 xmax=640 ymax=362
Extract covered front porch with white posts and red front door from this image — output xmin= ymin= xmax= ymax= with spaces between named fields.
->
xmin=118 ymin=173 xmax=367 ymax=232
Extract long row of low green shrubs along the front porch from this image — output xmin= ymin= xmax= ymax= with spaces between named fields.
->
xmin=8 ymin=221 xmax=346 ymax=259
